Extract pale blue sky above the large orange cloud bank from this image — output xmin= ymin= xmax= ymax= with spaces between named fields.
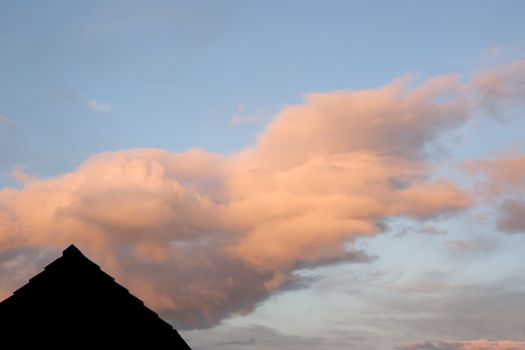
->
xmin=0 ymin=1 xmax=523 ymax=183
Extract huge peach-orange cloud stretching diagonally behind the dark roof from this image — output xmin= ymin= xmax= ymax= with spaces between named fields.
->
xmin=0 ymin=59 xmax=520 ymax=328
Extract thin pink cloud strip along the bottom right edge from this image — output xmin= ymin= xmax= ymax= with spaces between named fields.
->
xmin=396 ymin=339 xmax=525 ymax=350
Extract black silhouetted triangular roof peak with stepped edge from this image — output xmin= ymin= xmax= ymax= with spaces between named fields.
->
xmin=0 ymin=245 xmax=191 ymax=350
